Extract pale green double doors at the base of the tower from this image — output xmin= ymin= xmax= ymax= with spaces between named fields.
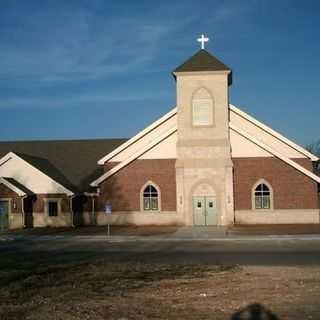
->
xmin=193 ymin=196 xmax=218 ymax=226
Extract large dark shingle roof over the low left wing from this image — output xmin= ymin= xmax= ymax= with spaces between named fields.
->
xmin=0 ymin=139 xmax=126 ymax=192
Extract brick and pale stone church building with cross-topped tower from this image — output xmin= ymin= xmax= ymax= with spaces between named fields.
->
xmin=0 ymin=37 xmax=320 ymax=229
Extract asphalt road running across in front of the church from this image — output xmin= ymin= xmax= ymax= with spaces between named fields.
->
xmin=0 ymin=238 xmax=320 ymax=266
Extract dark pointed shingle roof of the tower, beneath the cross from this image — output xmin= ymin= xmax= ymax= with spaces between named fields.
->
xmin=173 ymin=49 xmax=231 ymax=72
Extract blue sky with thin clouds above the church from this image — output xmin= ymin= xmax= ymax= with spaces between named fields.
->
xmin=0 ymin=0 xmax=320 ymax=144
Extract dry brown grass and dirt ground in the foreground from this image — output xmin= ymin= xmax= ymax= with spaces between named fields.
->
xmin=0 ymin=252 xmax=320 ymax=320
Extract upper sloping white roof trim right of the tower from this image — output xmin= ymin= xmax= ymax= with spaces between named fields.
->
xmin=229 ymin=104 xmax=319 ymax=161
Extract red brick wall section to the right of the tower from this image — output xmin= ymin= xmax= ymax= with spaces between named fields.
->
xmin=232 ymin=157 xmax=319 ymax=210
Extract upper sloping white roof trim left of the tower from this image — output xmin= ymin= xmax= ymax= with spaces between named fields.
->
xmin=98 ymin=108 xmax=177 ymax=165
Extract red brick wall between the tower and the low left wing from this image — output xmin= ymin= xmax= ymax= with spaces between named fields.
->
xmin=96 ymin=159 xmax=176 ymax=211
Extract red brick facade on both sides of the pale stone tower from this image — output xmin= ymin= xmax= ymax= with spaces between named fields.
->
xmin=97 ymin=157 xmax=319 ymax=211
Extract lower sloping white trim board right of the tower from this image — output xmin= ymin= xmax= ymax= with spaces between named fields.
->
xmin=229 ymin=123 xmax=320 ymax=183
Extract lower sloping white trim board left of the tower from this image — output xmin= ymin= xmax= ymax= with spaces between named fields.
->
xmin=90 ymin=126 xmax=177 ymax=187
